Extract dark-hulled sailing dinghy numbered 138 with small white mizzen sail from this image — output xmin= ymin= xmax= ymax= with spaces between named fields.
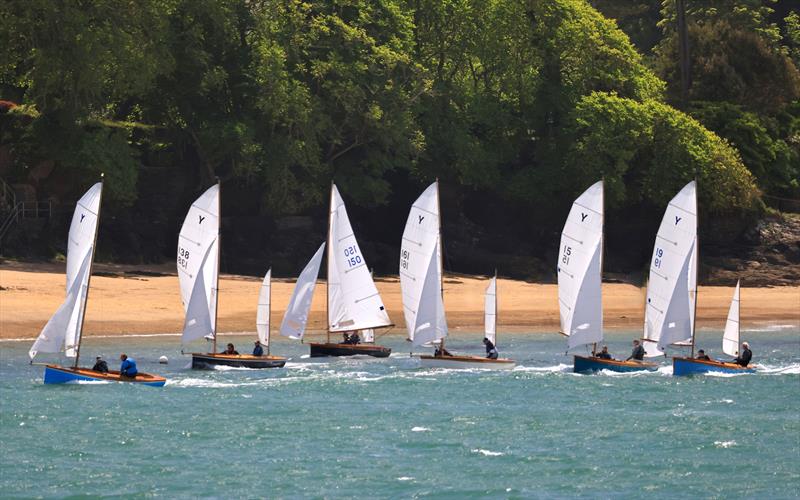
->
xmin=177 ymin=181 xmax=286 ymax=369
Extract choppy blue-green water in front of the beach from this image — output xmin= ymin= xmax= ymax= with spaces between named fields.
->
xmin=0 ymin=327 xmax=800 ymax=498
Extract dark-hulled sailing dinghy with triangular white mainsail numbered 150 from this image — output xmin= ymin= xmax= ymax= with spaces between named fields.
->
xmin=309 ymin=184 xmax=393 ymax=358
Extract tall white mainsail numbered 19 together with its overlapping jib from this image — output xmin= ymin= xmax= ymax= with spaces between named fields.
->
xmin=644 ymin=181 xmax=697 ymax=356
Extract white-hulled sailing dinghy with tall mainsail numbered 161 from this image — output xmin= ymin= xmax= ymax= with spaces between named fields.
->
xmin=400 ymin=181 xmax=515 ymax=370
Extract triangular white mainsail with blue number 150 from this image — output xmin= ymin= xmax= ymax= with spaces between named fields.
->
xmin=328 ymin=185 xmax=391 ymax=332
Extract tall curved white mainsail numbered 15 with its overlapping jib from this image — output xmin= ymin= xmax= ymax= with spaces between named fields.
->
xmin=558 ymin=181 xmax=603 ymax=349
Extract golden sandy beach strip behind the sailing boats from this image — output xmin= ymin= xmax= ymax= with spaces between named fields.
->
xmin=0 ymin=261 xmax=800 ymax=339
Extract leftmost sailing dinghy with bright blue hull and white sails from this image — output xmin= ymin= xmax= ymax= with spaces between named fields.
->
xmin=28 ymin=180 xmax=167 ymax=387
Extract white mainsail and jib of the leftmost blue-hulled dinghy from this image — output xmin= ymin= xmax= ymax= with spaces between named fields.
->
xmin=28 ymin=182 xmax=103 ymax=359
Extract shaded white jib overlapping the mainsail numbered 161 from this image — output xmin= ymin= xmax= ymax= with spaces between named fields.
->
xmin=411 ymin=240 xmax=447 ymax=346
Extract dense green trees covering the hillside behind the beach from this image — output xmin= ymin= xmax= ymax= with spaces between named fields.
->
xmin=0 ymin=0 xmax=800 ymax=275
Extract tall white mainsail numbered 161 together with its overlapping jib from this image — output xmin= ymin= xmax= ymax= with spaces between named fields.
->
xmin=400 ymin=182 xmax=447 ymax=345
